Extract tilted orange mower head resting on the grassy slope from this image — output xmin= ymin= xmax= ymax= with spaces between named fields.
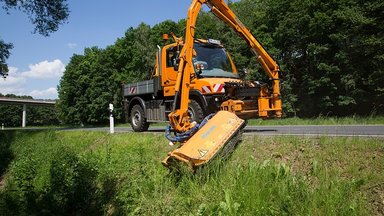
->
xmin=162 ymin=111 xmax=245 ymax=169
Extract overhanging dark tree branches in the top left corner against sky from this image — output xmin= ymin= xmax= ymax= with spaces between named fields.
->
xmin=0 ymin=0 xmax=69 ymax=77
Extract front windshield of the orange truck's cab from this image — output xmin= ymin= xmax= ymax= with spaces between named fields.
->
xmin=193 ymin=43 xmax=238 ymax=78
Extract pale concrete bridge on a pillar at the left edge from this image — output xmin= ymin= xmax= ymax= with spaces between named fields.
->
xmin=0 ymin=97 xmax=56 ymax=127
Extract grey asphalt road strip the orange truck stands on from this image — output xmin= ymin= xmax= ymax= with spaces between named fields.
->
xmin=57 ymin=125 xmax=384 ymax=137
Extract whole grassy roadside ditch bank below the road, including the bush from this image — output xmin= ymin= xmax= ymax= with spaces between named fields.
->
xmin=0 ymin=131 xmax=384 ymax=215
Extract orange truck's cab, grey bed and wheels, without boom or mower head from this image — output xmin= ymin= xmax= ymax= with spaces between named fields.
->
xmin=123 ymin=39 xmax=243 ymax=131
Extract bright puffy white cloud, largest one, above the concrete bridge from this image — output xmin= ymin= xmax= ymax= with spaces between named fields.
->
xmin=21 ymin=59 xmax=65 ymax=79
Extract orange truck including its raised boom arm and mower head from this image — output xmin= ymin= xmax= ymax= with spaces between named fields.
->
xmin=123 ymin=0 xmax=282 ymax=169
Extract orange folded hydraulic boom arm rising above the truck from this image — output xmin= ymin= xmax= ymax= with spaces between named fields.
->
xmin=168 ymin=0 xmax=282 ymax=132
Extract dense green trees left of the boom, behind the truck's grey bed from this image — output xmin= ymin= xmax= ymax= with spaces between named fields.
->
xmin=58 ymin=21 xmax=184 ymax=124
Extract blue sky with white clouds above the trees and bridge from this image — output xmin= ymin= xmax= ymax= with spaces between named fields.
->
xmin=0 ymin=0 xmax=191 ymax=99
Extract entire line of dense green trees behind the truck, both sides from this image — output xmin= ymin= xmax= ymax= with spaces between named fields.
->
xmin=57 ymin=0 xmax=384 ymax=124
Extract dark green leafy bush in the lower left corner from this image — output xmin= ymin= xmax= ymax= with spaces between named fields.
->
xmin=0 ymin=132 xmax=101 ymax=215
